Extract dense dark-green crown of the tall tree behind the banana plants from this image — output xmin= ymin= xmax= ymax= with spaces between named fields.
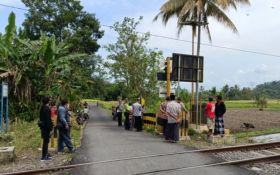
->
xmin=21 ymin=0 xmax=103 ymax=54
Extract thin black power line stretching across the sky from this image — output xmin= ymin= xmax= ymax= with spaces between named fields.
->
xmin=0 ymin=3 xmax=280 ymax=58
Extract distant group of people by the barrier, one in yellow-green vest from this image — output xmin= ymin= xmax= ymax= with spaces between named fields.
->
xmin=113 ymin=98 xmax=144 ymax=132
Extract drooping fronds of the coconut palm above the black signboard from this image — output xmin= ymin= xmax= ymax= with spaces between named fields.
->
xmin=154 ymin=0 xmax=250 ymax=42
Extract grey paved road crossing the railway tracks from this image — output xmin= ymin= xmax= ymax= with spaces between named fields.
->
xmin=71 ymin=106 xmax=254 ymax=175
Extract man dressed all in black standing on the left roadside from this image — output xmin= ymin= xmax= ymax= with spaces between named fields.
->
xmin=38 ymin=97 xmax=53 ymax=161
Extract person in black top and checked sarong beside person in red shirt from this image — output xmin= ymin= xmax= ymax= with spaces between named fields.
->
xmin=214 ymin=95 xmax=226 ymax=136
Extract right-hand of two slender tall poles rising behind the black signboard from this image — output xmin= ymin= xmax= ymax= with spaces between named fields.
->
xmin=195 ymin=13 xmax=201 ymax=129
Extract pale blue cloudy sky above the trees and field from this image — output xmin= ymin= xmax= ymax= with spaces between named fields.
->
xmin=0 ymin=0 xmax=280 ymax=89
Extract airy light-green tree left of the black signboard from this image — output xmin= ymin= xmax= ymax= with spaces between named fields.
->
xmin=105 ymin=17 xmax=162 ymax=100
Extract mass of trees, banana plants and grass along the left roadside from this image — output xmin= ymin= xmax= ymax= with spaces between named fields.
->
xmin=0 ymin=0 xmax=103 ymax=164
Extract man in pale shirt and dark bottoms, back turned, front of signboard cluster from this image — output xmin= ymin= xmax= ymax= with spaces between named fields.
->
xmin=165 ymin=95 xmax=182 ymax=142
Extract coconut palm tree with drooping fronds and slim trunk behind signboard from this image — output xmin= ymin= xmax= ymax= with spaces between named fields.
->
xmin=154 ymin=0 xmax=250 ymax=126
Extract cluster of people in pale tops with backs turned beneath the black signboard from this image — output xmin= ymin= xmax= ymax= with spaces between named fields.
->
xmin=160 ymin=95 xmax=187 ymax=143
